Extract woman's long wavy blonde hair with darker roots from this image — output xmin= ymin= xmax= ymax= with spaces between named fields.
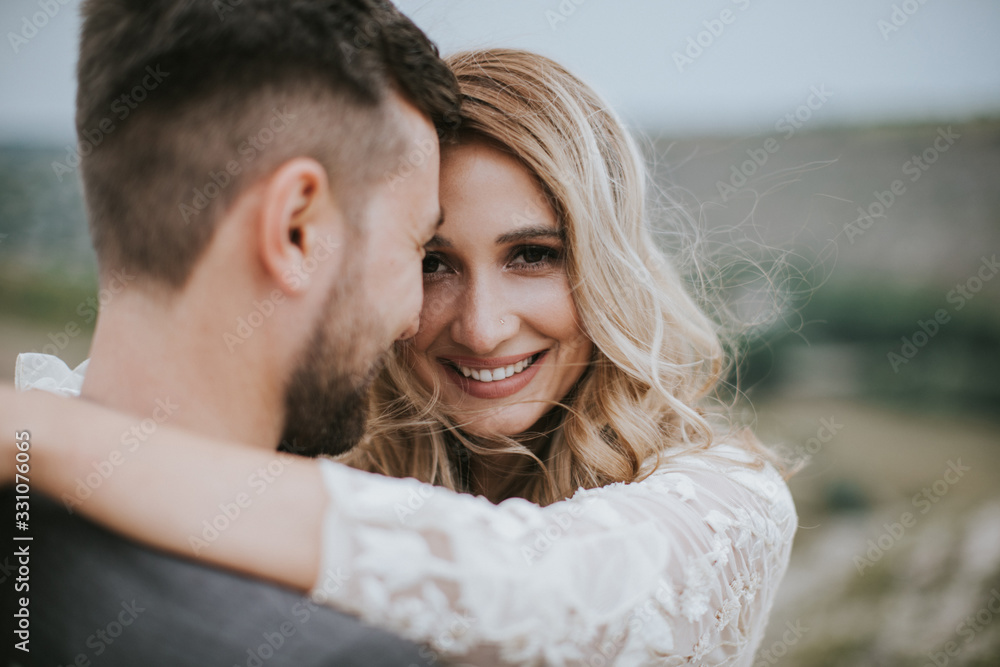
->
xmin=340 ymin=49 xmax=764 ymax=505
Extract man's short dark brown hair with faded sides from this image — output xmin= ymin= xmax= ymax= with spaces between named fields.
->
xmin=76 ymin=0 xmax=459 ymax=288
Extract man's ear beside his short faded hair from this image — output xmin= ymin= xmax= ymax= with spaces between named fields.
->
xmin=258 ymin=157 xmax=344 ymax=294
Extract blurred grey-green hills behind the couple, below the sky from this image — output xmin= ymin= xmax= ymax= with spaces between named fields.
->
xmin=0 ymin=119 xmax=1000 ymax=413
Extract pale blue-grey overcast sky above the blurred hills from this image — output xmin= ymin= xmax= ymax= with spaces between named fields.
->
xmin=0 ymin=0 xmax=1000 ymax=144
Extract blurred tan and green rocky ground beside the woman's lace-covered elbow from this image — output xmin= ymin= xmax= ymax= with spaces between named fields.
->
xmin=755 ymin=399 xmax=1000 ymax=667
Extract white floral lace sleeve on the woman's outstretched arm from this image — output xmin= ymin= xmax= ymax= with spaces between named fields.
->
xmin=313 ymin=446 xmax=797 ymax=666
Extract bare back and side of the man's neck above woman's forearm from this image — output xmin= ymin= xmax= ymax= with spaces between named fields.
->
xmin=81 ymin=293 xmax=283 ymax=449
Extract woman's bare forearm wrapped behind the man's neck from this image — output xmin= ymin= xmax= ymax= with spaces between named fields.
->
xmin=0 ymin=386 xmax=327 ymax=591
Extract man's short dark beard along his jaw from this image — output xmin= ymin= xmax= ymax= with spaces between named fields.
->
xmin=278 ymin=280 xmax=382 ymax=456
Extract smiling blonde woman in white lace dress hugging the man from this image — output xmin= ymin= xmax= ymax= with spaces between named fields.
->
xmin=0 ymin=50 xmax=796 ymax=665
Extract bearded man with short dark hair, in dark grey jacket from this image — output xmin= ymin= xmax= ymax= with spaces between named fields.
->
xmin=4 ymin=0 xmax=459 ymax=667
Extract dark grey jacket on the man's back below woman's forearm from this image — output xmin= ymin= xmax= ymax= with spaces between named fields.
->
xmin=0 ymin=487 xmax=433 ymax=667
